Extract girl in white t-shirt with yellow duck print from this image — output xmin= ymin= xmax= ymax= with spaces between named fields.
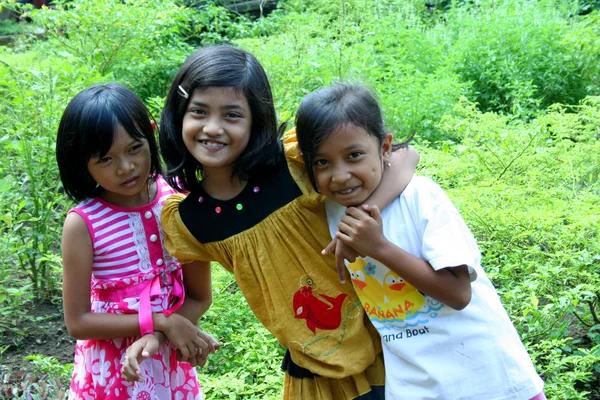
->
xmin=296 ymin=84 xmax=545 ymax=400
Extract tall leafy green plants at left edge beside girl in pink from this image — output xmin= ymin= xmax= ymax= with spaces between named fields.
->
xmin=0 ymin=50 xmax=102 ymax=300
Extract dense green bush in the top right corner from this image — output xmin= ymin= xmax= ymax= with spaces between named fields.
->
xmin=446 ymin=0 xmax=600 ymax=114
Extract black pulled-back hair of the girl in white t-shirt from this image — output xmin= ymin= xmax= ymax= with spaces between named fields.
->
xmin=296 ymin=83 xmax=412 ymax=191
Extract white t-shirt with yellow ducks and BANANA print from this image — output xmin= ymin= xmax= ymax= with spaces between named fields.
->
xmin=325 ymin=177 xmax=543 ymax=400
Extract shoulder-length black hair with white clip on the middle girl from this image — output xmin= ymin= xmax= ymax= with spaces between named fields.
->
xmin=159 ymin=45 xmax=283 ymax=191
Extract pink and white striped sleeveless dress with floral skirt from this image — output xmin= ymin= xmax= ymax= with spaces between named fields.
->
xmin=69 ymin=177 xmax=202 ymax=400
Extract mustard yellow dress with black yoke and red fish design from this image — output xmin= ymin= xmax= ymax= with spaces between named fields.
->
xmin=162 ymin=132 xmax=385 ymax=400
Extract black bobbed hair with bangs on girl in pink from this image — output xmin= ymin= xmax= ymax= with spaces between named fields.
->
xmin=56 ymin=83 xmax=162 ymax=201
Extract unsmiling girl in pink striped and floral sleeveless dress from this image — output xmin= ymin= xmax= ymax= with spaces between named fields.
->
xmin=56 ymin=84 xmax=218 ymax=400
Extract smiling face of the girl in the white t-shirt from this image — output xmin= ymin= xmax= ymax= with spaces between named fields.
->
xmin=312 ymin=125 xmax=392 ymax=207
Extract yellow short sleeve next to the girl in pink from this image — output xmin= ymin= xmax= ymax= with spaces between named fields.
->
xmin=161 ymin=194 xmax=214 ymax=264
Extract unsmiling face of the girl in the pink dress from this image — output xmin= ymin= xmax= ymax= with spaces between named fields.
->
xmin=87 ymin=125 xmax=151 ymax=207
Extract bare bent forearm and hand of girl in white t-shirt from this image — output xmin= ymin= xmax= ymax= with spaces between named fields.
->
xmin=336 ymin=206 xmax=471 ymax=310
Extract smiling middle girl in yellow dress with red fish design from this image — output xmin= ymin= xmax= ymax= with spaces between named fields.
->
xmin=155 ymin=46 xmax=418 ymax=400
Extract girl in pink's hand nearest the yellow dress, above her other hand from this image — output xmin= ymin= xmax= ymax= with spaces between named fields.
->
xmin=164 ymin=314 xmax=219 ymax=363
